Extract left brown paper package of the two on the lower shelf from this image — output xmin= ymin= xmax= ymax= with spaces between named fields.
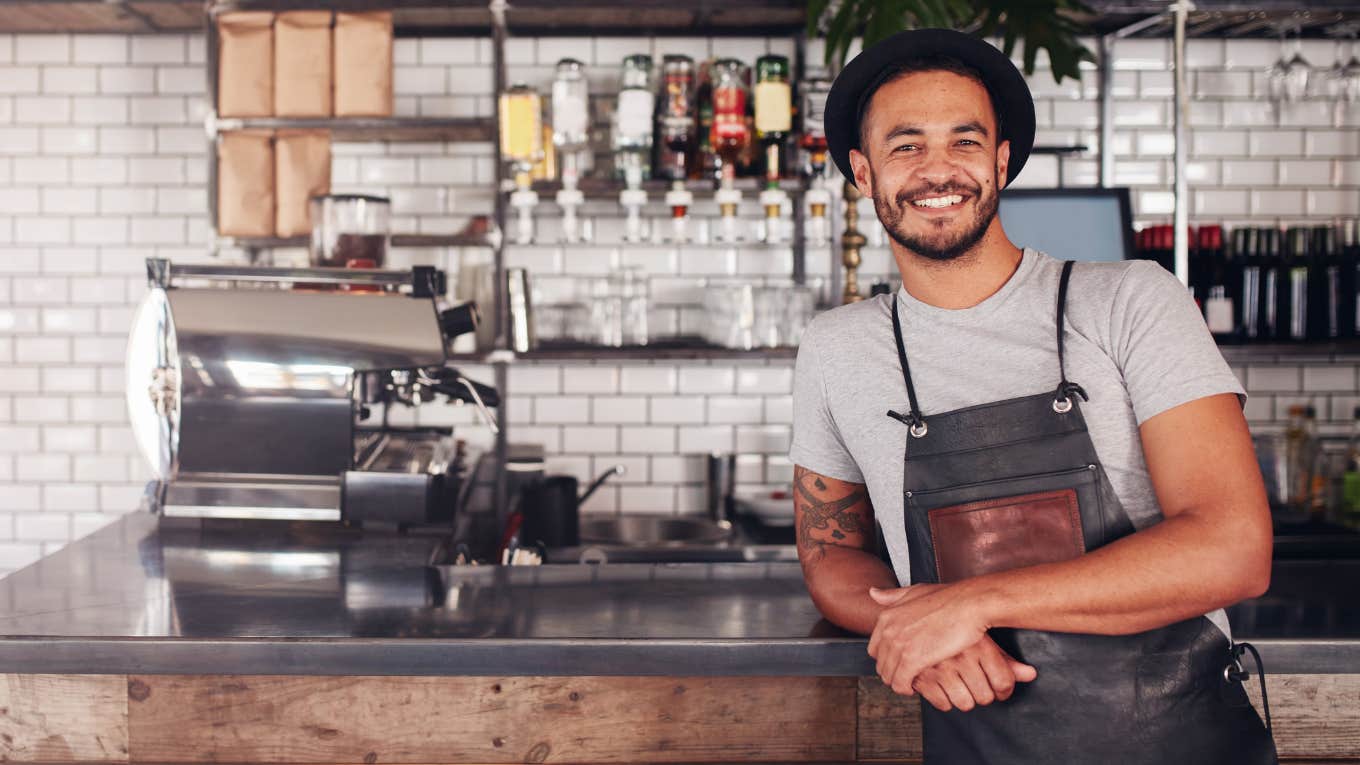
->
xmin=218 ymin=131 xmax=273 ymax=237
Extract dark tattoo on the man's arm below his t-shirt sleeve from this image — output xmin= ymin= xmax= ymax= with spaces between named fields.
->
xmin=793 ymin=457 xmax=873 ymax=565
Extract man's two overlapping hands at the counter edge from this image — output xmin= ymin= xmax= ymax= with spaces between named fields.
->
xmin=869 ymin=584 xmax=1038 ymax=711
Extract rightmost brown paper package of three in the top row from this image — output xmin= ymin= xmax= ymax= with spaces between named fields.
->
xmin=335 ymin=11 xmax=392 ymax=117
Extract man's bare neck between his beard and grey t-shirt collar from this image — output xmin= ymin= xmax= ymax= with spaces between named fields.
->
xmin=889 ymin=221 xmax=1023 ymax=310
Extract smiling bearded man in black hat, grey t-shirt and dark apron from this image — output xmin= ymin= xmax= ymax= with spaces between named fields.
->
xmin=790 ymin=30 xmax=1276 ymax=765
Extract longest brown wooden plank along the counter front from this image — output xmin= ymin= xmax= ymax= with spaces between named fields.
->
xmin=128 ymin=675 xmax=855 ymax=764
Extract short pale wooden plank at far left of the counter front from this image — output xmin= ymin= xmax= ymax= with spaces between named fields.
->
xmin=0 ymin=675 xmax=128 ymax=762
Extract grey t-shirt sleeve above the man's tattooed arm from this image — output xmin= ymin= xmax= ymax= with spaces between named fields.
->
xmin=789 ymin=323 xmax=864 ymax=483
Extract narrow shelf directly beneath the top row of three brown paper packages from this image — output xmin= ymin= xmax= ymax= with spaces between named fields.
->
xmin=217 ymin=117 xmax=495 ymax=143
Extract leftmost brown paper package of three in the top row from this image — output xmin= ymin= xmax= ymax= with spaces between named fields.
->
xmin=218 ymin=11 xmax=273 ymax=117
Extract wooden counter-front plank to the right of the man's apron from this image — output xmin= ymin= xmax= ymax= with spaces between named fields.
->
xmin=1247 ymin=674 xmax=1360 ymax=761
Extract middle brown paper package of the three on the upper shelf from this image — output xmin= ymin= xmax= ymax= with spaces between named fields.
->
xmin=273 ymin=11 xmax=330 ymax=117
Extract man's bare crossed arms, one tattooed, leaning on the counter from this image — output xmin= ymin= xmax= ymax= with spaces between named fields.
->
xmin=794 ymin=395 xmax=1272 ymax=709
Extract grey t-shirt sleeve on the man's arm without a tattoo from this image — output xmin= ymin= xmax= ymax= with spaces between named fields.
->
xmin=1110 ymin=261 xmax=1247 ymax=425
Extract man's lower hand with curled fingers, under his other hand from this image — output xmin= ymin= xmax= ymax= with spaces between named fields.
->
xmin=908 ymin=636 xmax=1039 ymax=712
